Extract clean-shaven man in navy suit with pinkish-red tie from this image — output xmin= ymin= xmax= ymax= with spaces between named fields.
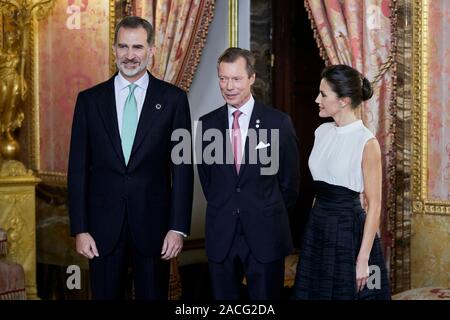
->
xmin=196 ymin=48 xmax=299 ymax=299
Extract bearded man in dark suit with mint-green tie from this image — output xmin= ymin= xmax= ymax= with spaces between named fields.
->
xmin=68 ymin=17 xmax=193 ymax=299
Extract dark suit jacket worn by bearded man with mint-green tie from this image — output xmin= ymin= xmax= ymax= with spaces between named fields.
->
xmin=67 ymin=73 xmax=193 ymax=256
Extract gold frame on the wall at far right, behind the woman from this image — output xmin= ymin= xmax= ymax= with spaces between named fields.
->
xmin=411 ymin=0 xmax=450 ymax=216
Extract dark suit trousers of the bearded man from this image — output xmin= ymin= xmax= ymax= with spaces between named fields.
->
xmin=89 ymin=218 xmax=169 ymax=300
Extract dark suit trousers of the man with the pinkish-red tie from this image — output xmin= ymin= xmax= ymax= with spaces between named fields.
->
xmin=209 ymin=221 xmax=284 ymax=300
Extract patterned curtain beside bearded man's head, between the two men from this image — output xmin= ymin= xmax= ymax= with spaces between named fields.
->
xmin=136 ymin=0 xmax=215 ymax=90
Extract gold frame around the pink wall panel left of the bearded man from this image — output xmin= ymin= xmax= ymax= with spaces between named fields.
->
xmin=27 ymin=0 xmax=116 ymax=187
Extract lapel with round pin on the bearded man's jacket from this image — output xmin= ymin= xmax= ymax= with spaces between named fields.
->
xmin=128 ymin=72 xmax=165 ymax=165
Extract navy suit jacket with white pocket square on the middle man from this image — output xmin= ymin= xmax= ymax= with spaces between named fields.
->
xmin=197 ymin=101 xmax=299 ymax=263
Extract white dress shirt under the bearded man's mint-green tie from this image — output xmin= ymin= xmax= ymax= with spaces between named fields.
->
xmin=114 ymin=72 xmax=187 ymax=237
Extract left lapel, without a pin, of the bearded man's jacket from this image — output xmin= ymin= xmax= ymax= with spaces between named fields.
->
xmin=97 ymin=73 xmax=125 ymax=166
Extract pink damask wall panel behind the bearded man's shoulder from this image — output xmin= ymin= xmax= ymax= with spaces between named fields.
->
xmin=38 ymin=0 xmax=111 ymax=174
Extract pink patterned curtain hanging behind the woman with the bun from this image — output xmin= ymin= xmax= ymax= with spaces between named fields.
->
xmin=305 ymin=0 xmax=395 ymax=272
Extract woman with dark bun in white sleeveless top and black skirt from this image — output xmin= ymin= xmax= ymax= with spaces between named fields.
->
xmin=294 ymin=65 xmax=390 ymax=300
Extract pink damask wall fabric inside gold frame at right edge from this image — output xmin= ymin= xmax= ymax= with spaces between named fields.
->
xmin=427 ymin=0 xmax=450 ymax=201
